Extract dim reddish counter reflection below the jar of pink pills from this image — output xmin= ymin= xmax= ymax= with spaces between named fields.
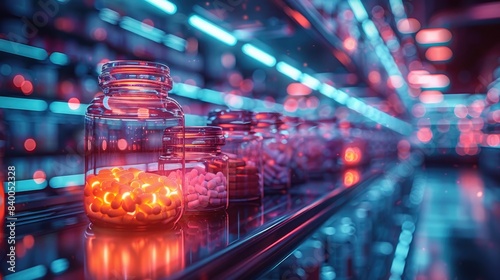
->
xmin=179 ymin=212 xmax=229 ymax=263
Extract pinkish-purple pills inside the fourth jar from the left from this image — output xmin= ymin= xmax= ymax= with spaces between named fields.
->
xmin=263 ymin=142 xmax=291 ymax=191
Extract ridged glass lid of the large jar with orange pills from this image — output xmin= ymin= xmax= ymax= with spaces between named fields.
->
xmin=99 ymin=60 xmax=173 ymax=92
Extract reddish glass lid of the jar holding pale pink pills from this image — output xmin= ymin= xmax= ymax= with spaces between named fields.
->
xmin=163 ymin=126 xmax=226 ymax=146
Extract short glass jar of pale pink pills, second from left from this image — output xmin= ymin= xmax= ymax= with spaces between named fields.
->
xmin=160 ymin=126 xmax=229 ymax=214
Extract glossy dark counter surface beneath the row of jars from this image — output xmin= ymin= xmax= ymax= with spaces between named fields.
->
xmin=1 ymin=163 xmax=394 ymax=279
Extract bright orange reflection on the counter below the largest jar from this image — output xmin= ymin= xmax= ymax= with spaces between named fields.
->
xmin=85 ymin=226 xmax=186 ymax=279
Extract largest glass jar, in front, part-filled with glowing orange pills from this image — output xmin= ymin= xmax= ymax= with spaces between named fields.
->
xmin=84 ymin=61 xmax=184 ymax=229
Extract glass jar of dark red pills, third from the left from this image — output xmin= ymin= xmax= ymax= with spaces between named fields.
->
xmin=207 ymin=110 xmax=264 ymax=202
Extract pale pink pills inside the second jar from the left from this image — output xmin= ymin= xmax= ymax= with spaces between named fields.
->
xmin=171 ymin=168 xmax=228 ymax=211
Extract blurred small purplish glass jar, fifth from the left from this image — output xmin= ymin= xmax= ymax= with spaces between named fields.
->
xmin=297 ymin=121 xmax=326 ymax=179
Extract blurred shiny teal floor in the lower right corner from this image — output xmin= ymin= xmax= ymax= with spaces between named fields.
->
xmin=409 ymin=168 xmax=500 ymax=280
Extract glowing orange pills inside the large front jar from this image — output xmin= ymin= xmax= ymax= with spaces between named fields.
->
xmin=84 ymin=167 xmax=182 ymax=225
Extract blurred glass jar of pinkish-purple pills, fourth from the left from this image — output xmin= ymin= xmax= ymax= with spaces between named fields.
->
xmin=254 ymin=112 xmax=292 ymax=193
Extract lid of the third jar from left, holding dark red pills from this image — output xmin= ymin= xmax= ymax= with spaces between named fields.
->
xmin=207 ymin=109 xmax=253 ymax=131
